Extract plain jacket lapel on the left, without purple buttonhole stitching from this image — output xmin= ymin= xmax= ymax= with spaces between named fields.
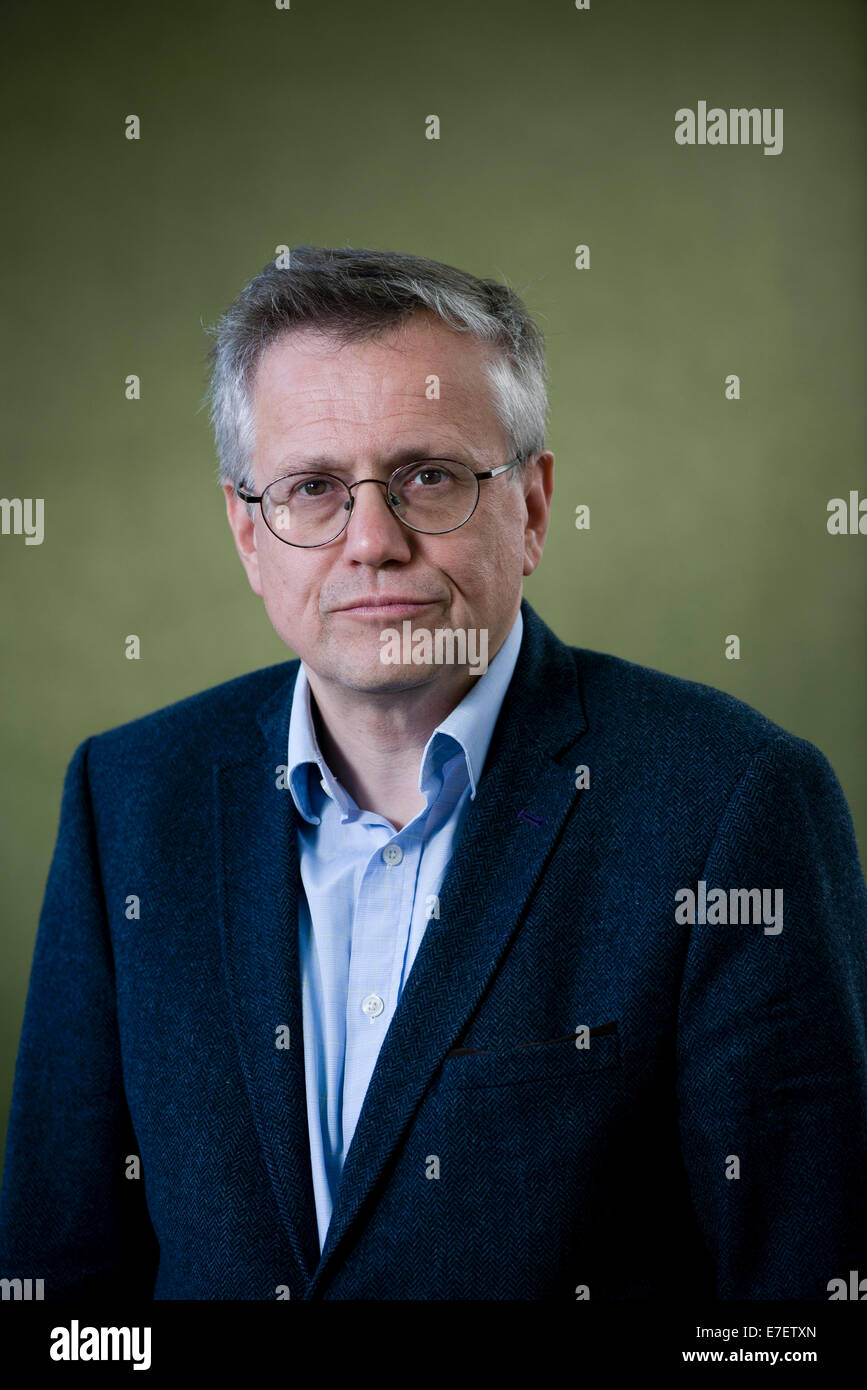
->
xmin=214 ymin=663 xmax=320 ymax=1282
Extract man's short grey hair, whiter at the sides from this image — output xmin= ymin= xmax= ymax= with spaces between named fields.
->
xmin=206 ymin=246 xmax=547 ymax=487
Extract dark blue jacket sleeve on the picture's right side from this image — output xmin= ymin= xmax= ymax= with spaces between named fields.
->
xmin=678 ymin=734 xmax=867 ymax=1300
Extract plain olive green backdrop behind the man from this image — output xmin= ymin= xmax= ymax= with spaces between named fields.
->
xmin=0 ymin=0 xmax=867 ymax=1173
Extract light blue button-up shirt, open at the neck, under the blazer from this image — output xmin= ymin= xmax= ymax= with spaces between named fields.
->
xmin=288 ymin=609 xmax=524 ymax=1248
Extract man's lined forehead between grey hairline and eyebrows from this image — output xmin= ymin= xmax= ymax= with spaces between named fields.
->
xmin=253 ymin=313 xmax=502 ymax=448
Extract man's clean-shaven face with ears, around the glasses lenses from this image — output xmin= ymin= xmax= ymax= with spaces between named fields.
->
xmin=224 ymin=305 xmax=553 ymax=692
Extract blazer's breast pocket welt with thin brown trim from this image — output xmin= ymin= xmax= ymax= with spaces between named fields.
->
xmin=438 ymin=1020 xmax=620 ymax=1090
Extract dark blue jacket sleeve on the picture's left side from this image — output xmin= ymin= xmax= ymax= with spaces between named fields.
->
xmin=0 ymin=741 xmax=158 ymax=1300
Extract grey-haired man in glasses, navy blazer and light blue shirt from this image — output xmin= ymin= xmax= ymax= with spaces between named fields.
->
xmin=0 ymin=247 xmax=867 ymax=1300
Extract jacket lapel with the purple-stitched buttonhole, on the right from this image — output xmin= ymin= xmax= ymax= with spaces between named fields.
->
xmin=310 ymin=599 xmax=586 ymax=1297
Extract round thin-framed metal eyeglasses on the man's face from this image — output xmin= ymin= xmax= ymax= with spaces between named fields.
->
xmin=235 ymin=457 xmax=522 ymax=548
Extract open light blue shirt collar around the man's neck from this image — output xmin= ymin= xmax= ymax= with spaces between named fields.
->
xmin=286 ymin=607 xmax=524 ymax=826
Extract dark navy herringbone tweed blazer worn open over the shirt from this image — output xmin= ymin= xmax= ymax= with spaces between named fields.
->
xmin=0 ymin=600 xmax=867 ymax=1301
